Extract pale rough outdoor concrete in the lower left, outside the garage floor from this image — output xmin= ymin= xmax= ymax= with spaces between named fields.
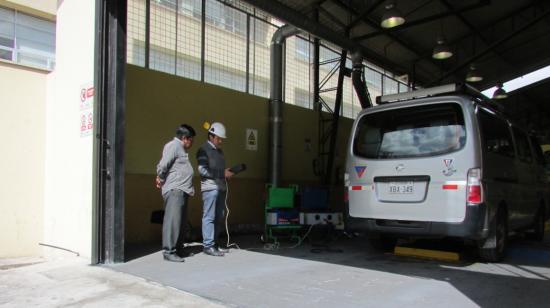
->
xmin=0 ymin=256 xmax=224 ymax=308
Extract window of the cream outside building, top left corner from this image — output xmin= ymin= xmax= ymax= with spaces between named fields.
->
xmin=0 ymin=8 xmax=55 ymax=70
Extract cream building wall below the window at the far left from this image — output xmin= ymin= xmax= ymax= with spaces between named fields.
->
xmin=0 ymin=62 xmax=48 ymax=258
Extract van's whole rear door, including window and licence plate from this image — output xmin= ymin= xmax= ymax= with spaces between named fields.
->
xmin=348 ymin=102 xmax=475 ymax=222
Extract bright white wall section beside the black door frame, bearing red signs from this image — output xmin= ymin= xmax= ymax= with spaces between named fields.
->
xmin=44 ymin=0 xmax=95 ymax=257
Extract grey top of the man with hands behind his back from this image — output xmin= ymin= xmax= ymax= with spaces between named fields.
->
xmin=157 ymin=138 xmax=195 ymax=196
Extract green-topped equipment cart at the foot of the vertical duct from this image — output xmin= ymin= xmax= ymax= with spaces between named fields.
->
xmin=264 ymin=185 xmax=302 ymax=245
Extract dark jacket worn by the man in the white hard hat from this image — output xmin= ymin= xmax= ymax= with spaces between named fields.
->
xmin=197 ymin=141 xmax=227 ymax=191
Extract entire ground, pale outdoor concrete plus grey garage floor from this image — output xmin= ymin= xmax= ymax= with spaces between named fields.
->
xmin=0 ymin=234 xmax=550 ymax=308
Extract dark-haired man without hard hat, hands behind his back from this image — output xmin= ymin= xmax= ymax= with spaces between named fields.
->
xmin=156 ymin=124 xmax=195 ymax=262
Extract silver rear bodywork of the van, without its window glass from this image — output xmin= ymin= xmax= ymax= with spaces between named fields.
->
xmin=346 ymin=96 xmax=481 ymax=223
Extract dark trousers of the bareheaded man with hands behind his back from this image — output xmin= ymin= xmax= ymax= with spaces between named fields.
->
xmin=162 ymin=189 xmax=189 ymax=254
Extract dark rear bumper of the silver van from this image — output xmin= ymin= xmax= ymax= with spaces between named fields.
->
xmin=346 ymin=204 xmax=488 ymax=240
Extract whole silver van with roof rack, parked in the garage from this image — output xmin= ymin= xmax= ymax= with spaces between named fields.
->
xmin=345 ymin=84 xmax=550 ymax=261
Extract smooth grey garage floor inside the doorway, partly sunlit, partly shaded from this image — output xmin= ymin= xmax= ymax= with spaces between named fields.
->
xmin=111 ymin=234 xmax=550 ymax=307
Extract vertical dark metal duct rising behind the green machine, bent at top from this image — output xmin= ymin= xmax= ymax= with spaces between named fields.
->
xmin=269 ymin=25 xmax=300 ymax=187
